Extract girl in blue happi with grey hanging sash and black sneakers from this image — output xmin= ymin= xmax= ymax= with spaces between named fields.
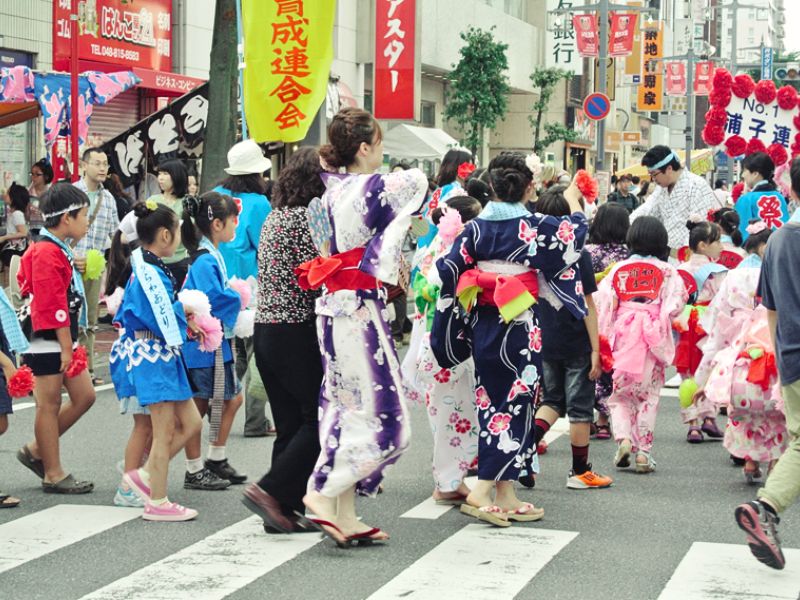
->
xmin=181 ymin=192 xmax=253 ymax=490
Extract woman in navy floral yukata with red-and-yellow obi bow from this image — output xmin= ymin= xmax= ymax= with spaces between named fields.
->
xmin=431 ymin=152 xmax=587 ymax=527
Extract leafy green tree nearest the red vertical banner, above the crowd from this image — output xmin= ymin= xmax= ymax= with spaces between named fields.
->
xmin=444 ymin=27 xmax=511 ymax=159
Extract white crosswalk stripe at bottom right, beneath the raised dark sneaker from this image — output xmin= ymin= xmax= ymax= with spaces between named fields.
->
xmin=658 ymin=542 xmax=800 ymax=600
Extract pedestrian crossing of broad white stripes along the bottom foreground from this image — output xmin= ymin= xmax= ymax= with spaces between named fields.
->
xmin=0 ymin=504 xmax=800 ymax=600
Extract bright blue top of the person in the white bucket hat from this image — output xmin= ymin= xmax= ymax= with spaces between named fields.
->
xmin=214 ymin=186 xmax=272 ymax=279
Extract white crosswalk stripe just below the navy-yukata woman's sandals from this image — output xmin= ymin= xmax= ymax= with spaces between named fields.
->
xmin=369 ymin=524 xmax=578 ymax=600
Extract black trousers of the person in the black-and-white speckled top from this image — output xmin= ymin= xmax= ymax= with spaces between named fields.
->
xmin=253 ymin=322 xmax=322 ymax=515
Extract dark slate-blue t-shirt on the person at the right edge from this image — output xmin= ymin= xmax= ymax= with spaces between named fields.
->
xmin=757 ymin=223 xmax=800 ymax=386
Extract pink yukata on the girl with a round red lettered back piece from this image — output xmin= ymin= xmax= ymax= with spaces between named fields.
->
xmin=595 ymin=256 xmax=687 ymax=454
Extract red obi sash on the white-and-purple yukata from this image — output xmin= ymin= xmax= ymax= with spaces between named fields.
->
xmin=294 ymin=248 xmax=379 ymax=292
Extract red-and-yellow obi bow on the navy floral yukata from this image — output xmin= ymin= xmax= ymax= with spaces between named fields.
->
xmin=456 ymin=269 xmax=539 ymax=323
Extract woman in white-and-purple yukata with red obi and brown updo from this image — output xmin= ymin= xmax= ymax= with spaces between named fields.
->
xmin=296 ymin=108 xmax=428 ymax=545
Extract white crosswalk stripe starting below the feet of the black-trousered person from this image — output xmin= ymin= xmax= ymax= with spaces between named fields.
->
xmin=83 ymin=517 xmax=320 ymax=600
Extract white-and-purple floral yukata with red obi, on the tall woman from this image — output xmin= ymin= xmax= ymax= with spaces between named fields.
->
xmin=300 ymin=169 xmax=428 ymax=498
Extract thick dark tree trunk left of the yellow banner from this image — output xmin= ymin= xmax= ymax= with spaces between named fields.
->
xmin=201 ymin=0 xmax=239 ymax=191
